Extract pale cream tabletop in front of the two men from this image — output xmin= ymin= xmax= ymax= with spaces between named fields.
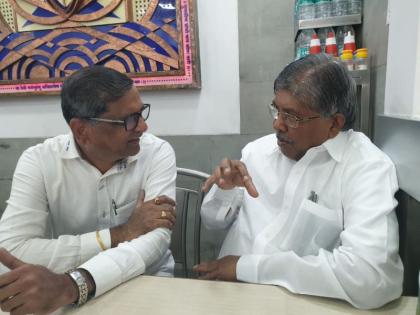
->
xmin=53 ymin=276 xmax=417 ymax=315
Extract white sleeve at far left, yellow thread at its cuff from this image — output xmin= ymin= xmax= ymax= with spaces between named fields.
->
xmin=0 ymin=148 xmax=104 ymax=272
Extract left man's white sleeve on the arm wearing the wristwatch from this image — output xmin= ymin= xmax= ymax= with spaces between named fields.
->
xmin=80 ymin=142 xmax=176 ymax=296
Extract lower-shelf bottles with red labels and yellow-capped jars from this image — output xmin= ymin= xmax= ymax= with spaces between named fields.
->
xmin=295 ymin=25 xmax=368 ymax=70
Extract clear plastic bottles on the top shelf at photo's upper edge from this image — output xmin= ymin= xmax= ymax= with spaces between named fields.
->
xmin=295 ymin=0 xmax=362 ymax=20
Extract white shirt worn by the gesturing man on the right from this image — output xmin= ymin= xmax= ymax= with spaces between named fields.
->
xmin=201 ymin=130 xmax=403 ymax=308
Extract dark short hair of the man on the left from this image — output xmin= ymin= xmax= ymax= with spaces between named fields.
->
xmin=61 ymin=66 xmax=133 ymax=123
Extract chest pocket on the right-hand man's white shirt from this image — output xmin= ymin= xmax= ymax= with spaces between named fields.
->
xmin=282 ymin=199 xmax=342 ymax=256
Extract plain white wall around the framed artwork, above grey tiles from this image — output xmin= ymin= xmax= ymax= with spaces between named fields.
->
xmin=0 ymin=0 xmax=240 ymax=138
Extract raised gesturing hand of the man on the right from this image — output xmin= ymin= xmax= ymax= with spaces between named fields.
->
xmin=202 ymin=159 xmax=258 ymax=198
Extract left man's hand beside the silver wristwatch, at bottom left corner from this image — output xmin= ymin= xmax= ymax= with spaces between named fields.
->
xmin=0 ymin=248 xmax=78 ymax=315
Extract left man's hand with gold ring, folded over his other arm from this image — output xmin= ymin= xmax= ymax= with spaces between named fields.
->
xmin=110 ymin=190 xmax=176 ymax=247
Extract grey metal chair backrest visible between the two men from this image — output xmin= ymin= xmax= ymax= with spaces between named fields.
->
xmin=171 ymin=168 xmax=210 ymax=278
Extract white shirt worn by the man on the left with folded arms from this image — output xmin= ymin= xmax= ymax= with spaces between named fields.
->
xmin=0 ymin=134 xmax=176 ymax=296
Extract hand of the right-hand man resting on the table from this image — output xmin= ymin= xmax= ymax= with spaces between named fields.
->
xmin=193 ymin=256 xmax=240 ymax=281
